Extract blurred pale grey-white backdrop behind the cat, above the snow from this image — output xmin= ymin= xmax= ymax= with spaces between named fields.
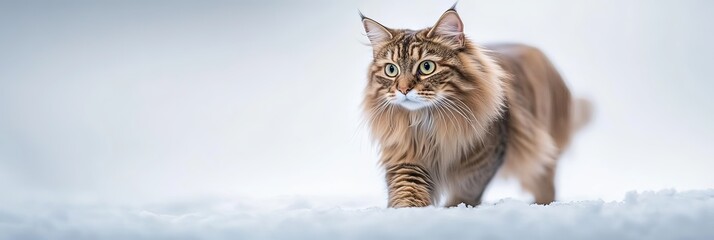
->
xmin=0 ymin=0 xmax=714 ymax=204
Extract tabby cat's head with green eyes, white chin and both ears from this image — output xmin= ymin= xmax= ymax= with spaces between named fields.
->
xmin=362 ymin=8 xmax=502 ymax=115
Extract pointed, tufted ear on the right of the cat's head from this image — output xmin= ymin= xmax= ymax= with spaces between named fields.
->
xmin=426 ymin=8 xmax=464 ymax=48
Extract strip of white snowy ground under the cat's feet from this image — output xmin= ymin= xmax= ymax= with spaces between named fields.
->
xmin=0 ymin=189 xmax=714 ymax=240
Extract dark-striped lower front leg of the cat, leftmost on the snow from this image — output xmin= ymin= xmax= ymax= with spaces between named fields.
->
xmin=386 ymin=163 xmax=435 ymax=208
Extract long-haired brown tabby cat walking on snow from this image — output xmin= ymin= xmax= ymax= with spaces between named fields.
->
xmin=362 ymin=7 xmax=589 ymax=207
